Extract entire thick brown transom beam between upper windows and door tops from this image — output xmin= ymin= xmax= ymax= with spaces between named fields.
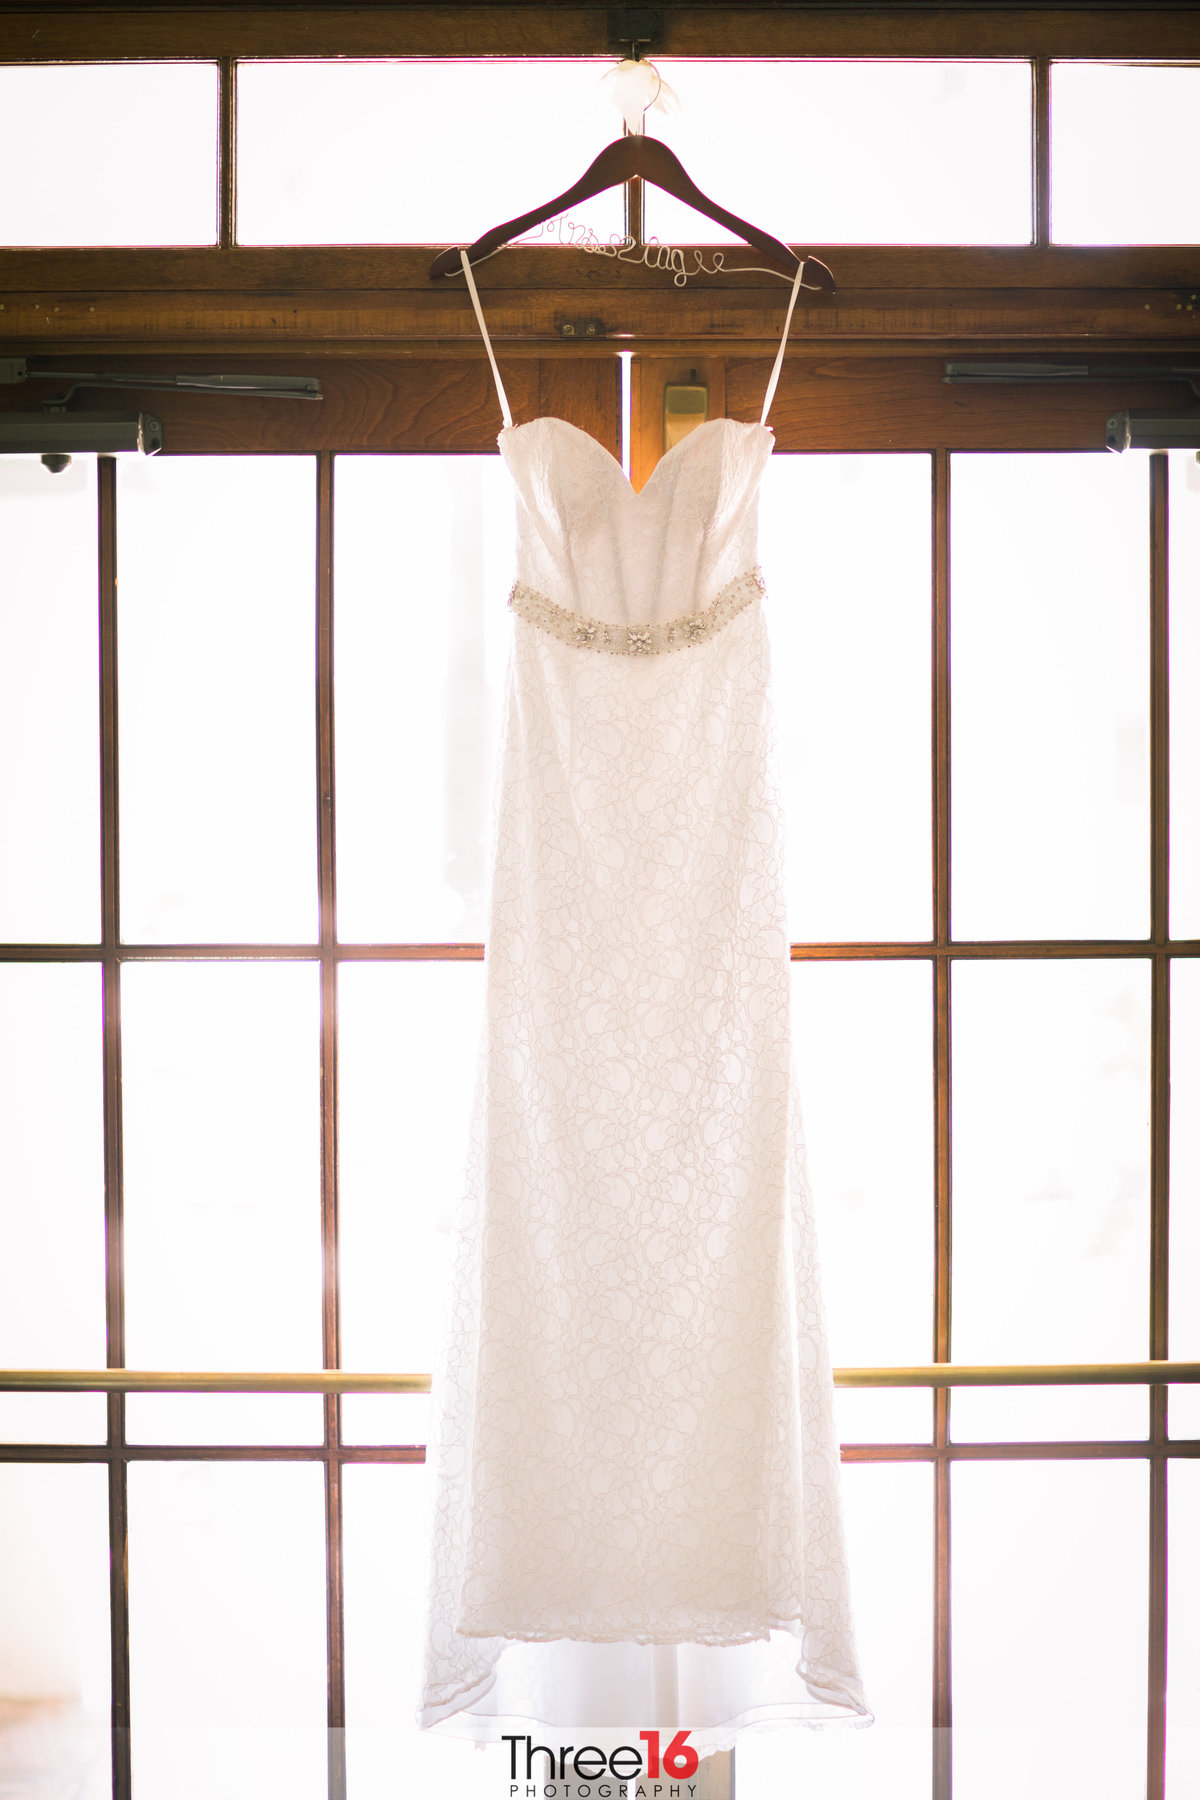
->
xmin=0 ymin=250 xmax=1200 ymax=358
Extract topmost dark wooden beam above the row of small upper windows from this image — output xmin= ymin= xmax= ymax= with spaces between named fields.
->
xmin=0 ymin=0 xmax=1200 ymax=61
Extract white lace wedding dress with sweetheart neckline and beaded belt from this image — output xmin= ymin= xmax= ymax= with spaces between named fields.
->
xmin=421 ymin=246 xmax=869 ymax=1753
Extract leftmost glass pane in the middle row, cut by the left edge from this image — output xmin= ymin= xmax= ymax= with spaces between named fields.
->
xmin=0 ymin=963 xmax=104 ymax=1444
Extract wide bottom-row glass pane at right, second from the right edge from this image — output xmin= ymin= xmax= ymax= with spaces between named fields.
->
xmin=952 ymin=1462 xmax=1148 ymax=1800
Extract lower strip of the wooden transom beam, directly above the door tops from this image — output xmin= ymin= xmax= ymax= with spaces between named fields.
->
xmin=9 ymin=284 xmax=1200 ymax=354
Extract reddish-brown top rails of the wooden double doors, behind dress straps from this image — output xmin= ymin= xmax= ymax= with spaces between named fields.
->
xmin=0 ymin=346 xmax=1182 ymax=450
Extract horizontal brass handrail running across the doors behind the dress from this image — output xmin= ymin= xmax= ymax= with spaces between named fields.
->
xmin=0 ymin=1363 xmax=1200 ymax=1393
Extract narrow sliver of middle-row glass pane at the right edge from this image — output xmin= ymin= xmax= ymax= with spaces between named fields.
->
xmin=1168 ymin=958 xmax=1200 ymax=1438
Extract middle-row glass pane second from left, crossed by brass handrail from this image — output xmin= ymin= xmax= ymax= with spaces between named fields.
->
xmin=122 ymin=963 xmax=320 ymax=1442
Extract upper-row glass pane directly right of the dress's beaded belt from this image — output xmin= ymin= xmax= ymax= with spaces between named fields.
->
xmin=759 ymin=455 xmax=930 ymax=941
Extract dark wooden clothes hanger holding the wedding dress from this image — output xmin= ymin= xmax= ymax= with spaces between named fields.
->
xmin=430 ymin=133 xmax=837 ymax=293
